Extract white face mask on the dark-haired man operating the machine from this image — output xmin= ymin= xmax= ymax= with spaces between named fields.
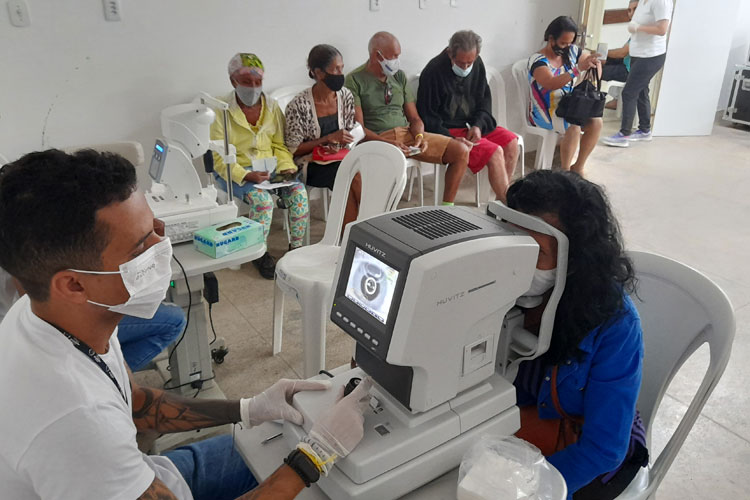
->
xmin=70 ymin=238 xmax=172 ymax=319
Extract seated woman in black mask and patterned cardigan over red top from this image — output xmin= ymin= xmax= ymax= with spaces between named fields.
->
xmin=285 ymin=45 xmax=364 ymax=226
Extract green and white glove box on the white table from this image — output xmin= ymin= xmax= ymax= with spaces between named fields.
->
xmin=193 ymin=217 xmax=263 ymax=259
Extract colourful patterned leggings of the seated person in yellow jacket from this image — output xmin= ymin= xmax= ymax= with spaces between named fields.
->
xmin=246 ymin=183 xmax=310 ymax=248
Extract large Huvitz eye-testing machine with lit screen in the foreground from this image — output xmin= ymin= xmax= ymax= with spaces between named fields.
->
xmin=284 ymin=203 xmax=568 ymax=500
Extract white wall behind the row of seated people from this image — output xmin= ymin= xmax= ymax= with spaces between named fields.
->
xmin=0 ymin=0 xmax=578 ymax=170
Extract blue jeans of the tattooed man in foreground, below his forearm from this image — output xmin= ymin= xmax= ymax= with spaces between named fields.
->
xmin=163 ymin=434 xmax=258 ymax=500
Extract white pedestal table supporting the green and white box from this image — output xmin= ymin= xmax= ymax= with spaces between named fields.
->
xmin=160 ymin=242 xmax=266 ymax=397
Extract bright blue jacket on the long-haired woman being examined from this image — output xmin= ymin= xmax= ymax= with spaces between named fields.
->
xmin=517 ymin=296 xmax=643 ymax=498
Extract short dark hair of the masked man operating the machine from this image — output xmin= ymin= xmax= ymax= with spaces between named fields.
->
xmin=0 ymin=149 xmax=136 ymax=301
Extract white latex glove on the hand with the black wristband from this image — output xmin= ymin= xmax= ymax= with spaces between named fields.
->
xmin=304 ymin=377 xmax=372 ymax=463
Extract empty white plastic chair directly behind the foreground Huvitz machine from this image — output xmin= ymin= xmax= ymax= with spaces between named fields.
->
xmin=273 ymin=141 xmax=406 ymax=378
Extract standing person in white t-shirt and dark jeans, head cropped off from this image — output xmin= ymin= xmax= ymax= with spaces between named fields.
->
xmin=602 ymin=0 xmax=673 ymax=148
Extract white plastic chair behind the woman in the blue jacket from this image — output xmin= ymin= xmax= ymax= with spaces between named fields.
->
xmin=617 ymin=252 xmax=735 ymax=500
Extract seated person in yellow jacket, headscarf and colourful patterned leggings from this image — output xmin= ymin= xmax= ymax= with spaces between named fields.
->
xmin=211 ymin=53 xmax=309 ymax=280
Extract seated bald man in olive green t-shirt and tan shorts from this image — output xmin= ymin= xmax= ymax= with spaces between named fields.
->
xmin=345 ymin=31 xmax=469 ymax=205
